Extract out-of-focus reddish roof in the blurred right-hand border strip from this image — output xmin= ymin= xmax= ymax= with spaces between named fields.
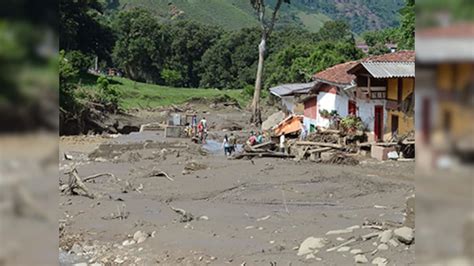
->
xmin=416 ymin=23 xmax=474 ymax=38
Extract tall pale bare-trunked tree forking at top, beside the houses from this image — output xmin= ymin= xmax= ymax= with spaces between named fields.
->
xmin=250 ymin=0 xmax=290 ymax=125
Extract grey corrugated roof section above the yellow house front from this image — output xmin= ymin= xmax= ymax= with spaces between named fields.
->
xmin=361 ymin=62 xmax=415 ymax=78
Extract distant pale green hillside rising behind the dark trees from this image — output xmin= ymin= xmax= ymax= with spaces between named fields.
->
xmin=104 ymin=0 xmax=404 ymax=33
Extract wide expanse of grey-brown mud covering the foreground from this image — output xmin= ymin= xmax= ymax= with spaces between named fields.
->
xmin=59 ymin=106 xmax=415 ymax=265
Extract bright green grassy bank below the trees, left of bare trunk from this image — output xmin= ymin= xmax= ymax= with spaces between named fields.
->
xmin=78 ymin=75 xmax=249 ymax=110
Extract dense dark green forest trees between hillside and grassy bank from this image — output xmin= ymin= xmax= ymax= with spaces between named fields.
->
xmin=59 ymin=0 xmax=414 ymax=131
